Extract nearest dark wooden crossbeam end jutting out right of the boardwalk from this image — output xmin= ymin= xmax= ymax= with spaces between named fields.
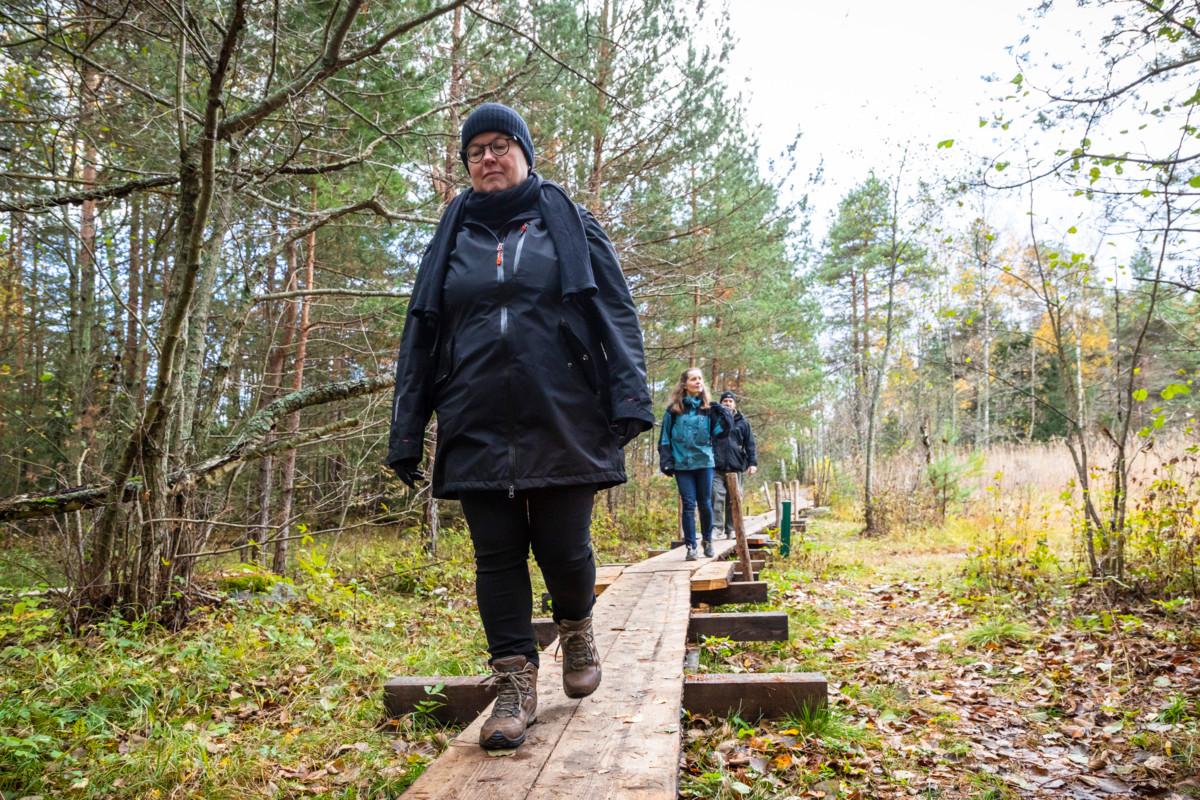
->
xmin=683 ymin=672 xmax=829 ymax=721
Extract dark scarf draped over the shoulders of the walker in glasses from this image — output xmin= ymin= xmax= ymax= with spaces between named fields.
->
xmin=408 ymin=173 xmax=596 ymax=326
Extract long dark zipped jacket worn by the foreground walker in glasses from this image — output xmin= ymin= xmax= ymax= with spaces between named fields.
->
xmin=388 ymin=209 xmax=654 ymax=498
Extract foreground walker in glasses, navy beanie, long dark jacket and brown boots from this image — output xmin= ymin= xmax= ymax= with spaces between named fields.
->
xmin=388 ymin=103 xmax=654 ymax=748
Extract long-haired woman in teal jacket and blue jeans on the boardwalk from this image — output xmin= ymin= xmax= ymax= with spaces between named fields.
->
xmin=659 ymin=367 xmax=733 ymax=561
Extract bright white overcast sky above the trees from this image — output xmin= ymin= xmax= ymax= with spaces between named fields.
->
xmin=728 ymin=0 xmax=1082 ymax=247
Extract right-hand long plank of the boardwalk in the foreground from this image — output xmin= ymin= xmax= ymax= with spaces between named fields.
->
xmin=528 ymin=571 xmax=690 ymax=800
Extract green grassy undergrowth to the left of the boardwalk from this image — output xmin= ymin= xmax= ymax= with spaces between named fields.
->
xmin=0 ymin=530 xmax=485 ymax=799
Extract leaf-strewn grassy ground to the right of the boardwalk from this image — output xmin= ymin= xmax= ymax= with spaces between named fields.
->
xmin=680 ymin=518 xmax=1200 ymax=800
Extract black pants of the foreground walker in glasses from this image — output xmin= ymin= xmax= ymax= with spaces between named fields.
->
xmin=460 ymin=486 xmax=596 ymax=664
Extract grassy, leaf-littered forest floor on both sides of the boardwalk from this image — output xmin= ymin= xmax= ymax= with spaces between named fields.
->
xmin=0 ymin=506 xmax=1200 ymax=800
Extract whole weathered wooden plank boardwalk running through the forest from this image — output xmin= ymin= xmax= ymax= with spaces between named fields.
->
xmin=404 ymin=515 xmax=772 ymax=800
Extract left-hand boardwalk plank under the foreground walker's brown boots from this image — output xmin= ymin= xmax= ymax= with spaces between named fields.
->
xmin=404 ymin=573 xmax=667 ymax=800
